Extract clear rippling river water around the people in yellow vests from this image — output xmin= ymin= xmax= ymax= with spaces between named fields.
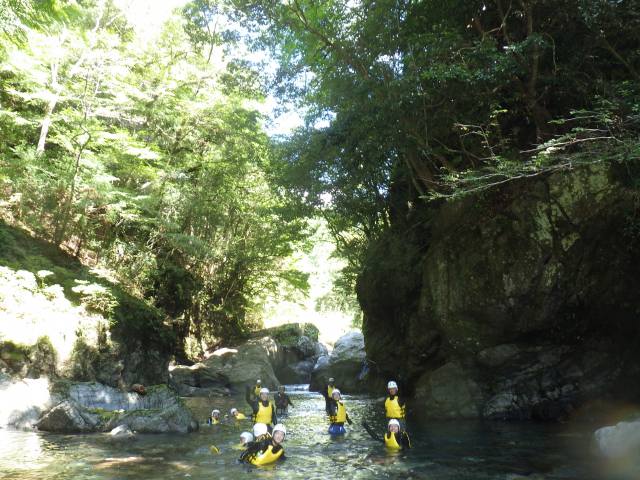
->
xmin=0 ymin=388 xmax=640 ymax=480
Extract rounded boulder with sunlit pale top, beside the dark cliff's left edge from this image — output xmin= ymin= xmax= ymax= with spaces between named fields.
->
xmin=310 ymin=332 xmax=366 ymax=393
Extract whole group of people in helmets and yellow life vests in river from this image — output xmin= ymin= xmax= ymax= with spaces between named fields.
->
xmin=207 ymin=378 xmax=411 ymax=465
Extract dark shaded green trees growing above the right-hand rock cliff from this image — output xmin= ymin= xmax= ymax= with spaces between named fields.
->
xmin=233 ymin=0 xmax=640 ymax=296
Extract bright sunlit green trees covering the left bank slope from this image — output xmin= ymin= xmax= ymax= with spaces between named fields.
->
xmin=0 ymin=0 xmax=307 ymax=356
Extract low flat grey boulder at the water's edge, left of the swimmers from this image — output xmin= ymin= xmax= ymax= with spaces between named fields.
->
xmin=36 ymin=382 xmax=198 ymax=433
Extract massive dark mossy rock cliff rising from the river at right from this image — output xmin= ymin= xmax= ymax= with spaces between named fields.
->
xmin=357 ymin=165 xmax=640 ymax=420
